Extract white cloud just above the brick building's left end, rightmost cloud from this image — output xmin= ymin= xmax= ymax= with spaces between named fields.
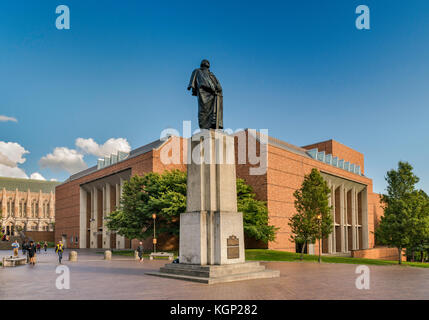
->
xmin=76 ymin=138 xmax=131 ymax=157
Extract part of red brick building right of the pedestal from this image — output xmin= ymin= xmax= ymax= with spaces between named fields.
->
xmin=237 ymin=131 xmax=382 ymax=253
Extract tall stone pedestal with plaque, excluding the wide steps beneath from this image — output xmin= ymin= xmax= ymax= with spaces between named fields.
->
xmin=179 ymin=130 xmax=244 ymax=265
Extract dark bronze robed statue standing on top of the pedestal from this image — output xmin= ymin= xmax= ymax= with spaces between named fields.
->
xmin=188 ymin=60 xmax=223 ymax=129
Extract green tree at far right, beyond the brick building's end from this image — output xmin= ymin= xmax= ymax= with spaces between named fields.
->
xmin=375 ymin=162 xmax=426 ymax=264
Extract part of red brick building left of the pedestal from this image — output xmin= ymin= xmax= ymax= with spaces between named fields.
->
xmin=55 ymin=137 xmax=186 ymax=249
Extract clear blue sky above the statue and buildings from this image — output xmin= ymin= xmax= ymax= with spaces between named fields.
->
xmin=0 ymin=0 xmax=429 ymax=192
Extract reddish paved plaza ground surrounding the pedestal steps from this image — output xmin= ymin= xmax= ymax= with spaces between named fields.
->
xmin=0 ymin=249 xmax=429 ymax=300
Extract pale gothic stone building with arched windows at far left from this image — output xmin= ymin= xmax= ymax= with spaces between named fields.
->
xmin=0 ymin=177 xmax=59 ymax=241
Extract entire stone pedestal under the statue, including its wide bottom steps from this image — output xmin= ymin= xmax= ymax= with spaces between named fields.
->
xmin=149 ymin=130 xmax=279 ymax=284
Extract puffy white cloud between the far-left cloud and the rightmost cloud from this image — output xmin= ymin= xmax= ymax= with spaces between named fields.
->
xmin=39 ymin=147 xmax=88 ymax=174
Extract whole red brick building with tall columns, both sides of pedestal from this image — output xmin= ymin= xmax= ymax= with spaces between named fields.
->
xmin=55 ymin=130 xmax=382 ymax=253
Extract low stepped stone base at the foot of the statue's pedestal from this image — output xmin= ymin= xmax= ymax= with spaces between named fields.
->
xmin=146 ymin=262 xmax=280 ymax=284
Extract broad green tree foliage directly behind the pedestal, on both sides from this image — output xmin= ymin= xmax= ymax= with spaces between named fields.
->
xmin=107 ymin=170 xmax=277 ymax=242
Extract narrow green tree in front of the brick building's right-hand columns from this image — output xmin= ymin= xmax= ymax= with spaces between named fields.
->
xmin=289 ymin=168 xmax=333 ymax=263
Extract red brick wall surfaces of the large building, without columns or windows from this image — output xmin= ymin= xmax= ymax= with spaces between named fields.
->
xmin=55 ymin=131 xmax=382 ymax=255
